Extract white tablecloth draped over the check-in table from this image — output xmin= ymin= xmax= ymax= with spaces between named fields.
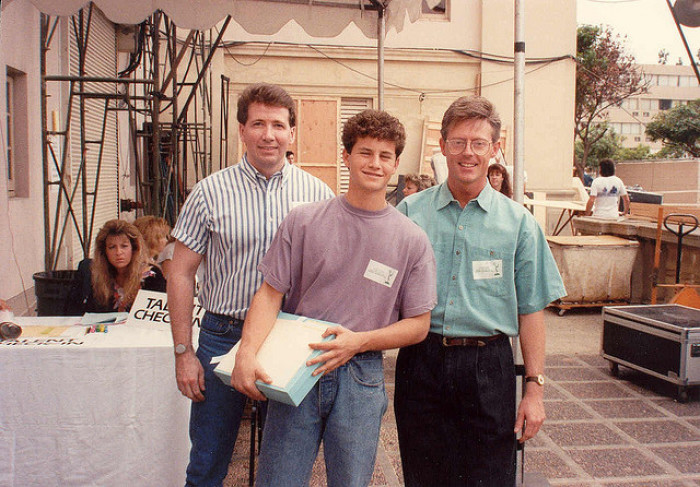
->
xmin=0 ymin=318 xmax=190 ymax=487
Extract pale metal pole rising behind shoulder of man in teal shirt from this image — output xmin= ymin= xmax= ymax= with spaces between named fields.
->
xmin=513 ymin=0 xmax=525 ymax=203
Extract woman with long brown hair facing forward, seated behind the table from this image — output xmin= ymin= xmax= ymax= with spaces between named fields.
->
xmin=66 ymin=220 xmax=165 ymax=315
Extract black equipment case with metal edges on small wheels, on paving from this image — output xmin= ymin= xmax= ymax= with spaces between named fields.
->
xmin=602 ymin=304 xmax=700 ymax=401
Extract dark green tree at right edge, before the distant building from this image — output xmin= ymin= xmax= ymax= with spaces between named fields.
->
xmin=646 ymin=98 xmax=700 ymax=157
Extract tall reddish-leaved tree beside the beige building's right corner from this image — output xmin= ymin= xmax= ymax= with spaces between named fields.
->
xmin=574 ymin=25 xmax=646 ymax=178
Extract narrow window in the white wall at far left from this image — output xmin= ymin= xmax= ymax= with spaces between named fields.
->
xmin=5 ymin=66 xmax=29 ymax=197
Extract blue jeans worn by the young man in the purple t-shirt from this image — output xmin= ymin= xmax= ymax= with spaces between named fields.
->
xmin=255 ymin=352 xmax=387 ymax=487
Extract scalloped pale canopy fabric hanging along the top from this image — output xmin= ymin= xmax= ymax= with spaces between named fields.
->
xmin=17 ymin=0 xmax=440 ymax=38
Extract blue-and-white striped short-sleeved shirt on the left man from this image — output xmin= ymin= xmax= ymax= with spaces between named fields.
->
xmin=172 ymin=155 xmax=334 ymax=319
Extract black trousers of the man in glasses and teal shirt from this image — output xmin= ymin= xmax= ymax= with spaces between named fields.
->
xmin=394 ymin=333 xmax=515 ymax=487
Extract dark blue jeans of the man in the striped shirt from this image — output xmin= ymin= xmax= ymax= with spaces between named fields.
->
xmin=186 ymin=313 xmax=246 ymax=487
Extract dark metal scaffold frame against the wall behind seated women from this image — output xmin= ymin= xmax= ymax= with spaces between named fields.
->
xmin=40 ymin=3 xmax=231 ymax=271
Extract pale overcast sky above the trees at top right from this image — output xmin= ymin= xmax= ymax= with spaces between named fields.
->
xmin=576 ymin=0 xmax=700 ymax=66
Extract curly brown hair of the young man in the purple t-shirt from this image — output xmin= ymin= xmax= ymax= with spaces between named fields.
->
xmin=343 ymin=109 xmax=406 ymax=157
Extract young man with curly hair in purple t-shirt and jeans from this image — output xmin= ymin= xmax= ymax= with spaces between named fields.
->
xmin=231 ymin=110 xmax=437 ymax=487
